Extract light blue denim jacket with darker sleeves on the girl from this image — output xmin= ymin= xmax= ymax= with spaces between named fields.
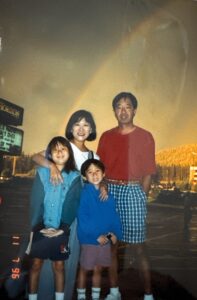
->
xmin=30 ymin=167 xmax=82 ymax=228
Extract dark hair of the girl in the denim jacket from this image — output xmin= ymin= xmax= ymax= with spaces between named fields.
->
xmin=45 ymin=136 xmax=76 ymax=173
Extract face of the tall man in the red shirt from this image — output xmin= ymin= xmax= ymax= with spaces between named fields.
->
xmin=114 ymin=98 xmax=136 ymax=125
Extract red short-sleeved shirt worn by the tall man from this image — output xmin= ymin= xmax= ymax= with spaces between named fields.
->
xmin=97 ymin=127 xmax=156 ymax=180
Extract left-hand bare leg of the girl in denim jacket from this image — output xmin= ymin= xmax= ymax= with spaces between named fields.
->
xmin=29 ymin=258 xmax=43 ymax=299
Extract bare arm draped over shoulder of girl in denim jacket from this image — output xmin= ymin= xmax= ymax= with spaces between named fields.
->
xmin=32 ymin=151 xmax=63 ymax=184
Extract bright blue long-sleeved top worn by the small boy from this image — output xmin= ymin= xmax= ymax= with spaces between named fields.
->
xmin=77 ymin=183 xmax=122 ymax=245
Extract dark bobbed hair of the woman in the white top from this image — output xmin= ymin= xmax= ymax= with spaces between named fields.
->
xmin=65 ymin=109 xmax=96 ymax=141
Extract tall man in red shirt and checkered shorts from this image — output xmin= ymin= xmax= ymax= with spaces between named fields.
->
xmin=97 ymin=92 xmax=156 ymax=300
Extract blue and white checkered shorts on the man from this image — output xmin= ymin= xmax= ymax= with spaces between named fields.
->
xmin=108 ymin=184 xmax=147 ymax=244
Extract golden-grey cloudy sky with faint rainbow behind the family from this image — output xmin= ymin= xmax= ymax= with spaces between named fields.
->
xmin=0 ymin=0 xmax=197 ymax=153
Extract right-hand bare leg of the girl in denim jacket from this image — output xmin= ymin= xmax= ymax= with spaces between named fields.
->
xmin=52 ymin=260 xmax=65 ymax=300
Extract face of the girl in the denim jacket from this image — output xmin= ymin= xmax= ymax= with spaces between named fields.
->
xmin=51 ymin=143 xmax=69 ymax=167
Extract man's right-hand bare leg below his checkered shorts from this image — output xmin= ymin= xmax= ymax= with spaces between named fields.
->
xmin=133 ymin=243 xmax=153 ymax=299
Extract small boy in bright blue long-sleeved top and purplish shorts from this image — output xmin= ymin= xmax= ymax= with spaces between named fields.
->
xmin=77 ymin=159 xmax=122 ymax=300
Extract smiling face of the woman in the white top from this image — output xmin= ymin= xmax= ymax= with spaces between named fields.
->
xmin=72 ymin=118 xmax=92 ymax=142
